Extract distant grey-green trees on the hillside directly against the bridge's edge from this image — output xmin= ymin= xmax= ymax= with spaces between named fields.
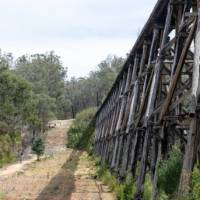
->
xmin=66 ymin=56 xmax=124 ymax=116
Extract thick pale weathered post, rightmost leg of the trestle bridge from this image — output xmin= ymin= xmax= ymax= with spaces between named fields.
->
xmin=178 ymin=0 xmax=200 ymax=199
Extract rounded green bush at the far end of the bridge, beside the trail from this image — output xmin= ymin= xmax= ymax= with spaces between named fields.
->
xmin=67 ymin=108 xmax=96 ymax=149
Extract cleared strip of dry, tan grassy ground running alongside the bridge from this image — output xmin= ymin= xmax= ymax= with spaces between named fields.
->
xmin=0 ymin=120 xmax=116 ymax=200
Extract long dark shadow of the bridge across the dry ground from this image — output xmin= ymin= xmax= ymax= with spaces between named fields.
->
xmin=36 ymin=150 xmax=82 ymax=200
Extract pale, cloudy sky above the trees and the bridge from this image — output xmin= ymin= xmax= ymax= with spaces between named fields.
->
xmin=0 ymin=0 xmax=156 ymax=77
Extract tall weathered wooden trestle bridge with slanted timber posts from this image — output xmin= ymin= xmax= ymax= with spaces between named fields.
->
xmin=95 ymin=0 xmax=200 ymax=200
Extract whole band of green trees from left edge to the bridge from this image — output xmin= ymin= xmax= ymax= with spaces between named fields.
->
xmin=0 ymin=52 xmax=124 ymax=166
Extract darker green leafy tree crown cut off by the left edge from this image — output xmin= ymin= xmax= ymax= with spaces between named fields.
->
xmin=0 ymin=70 xmax=32 ymax=125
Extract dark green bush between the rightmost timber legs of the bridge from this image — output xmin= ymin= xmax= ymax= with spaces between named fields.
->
xmin=158 ymin=148 xmax=183 ymax=196
